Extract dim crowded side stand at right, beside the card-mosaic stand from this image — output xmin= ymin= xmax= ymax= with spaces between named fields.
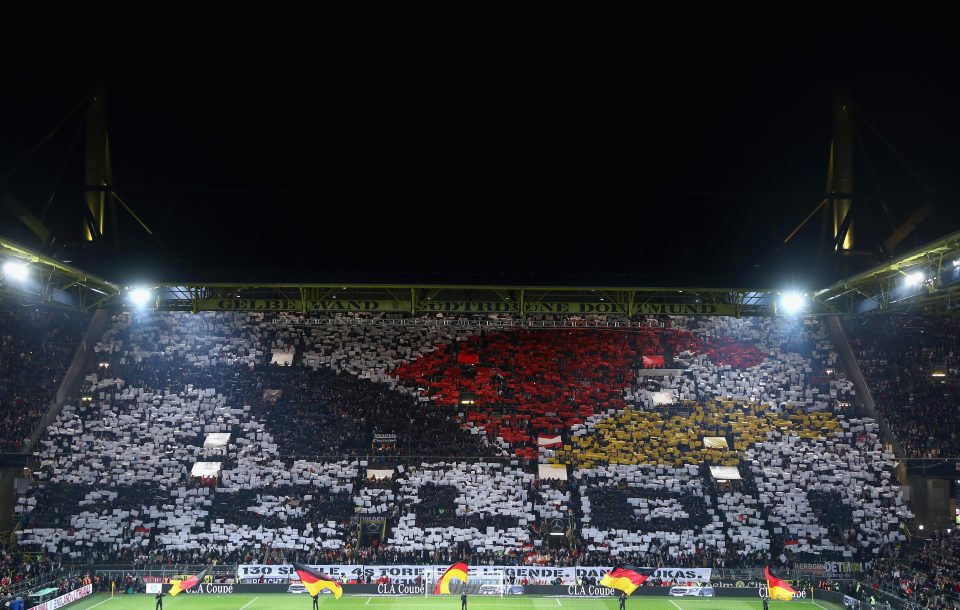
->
xmin=847 ymin=316 xmax=960 ymax=458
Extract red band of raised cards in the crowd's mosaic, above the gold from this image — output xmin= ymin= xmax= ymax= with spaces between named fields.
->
xmin=393 ymin=329 xmax=699 ymax=459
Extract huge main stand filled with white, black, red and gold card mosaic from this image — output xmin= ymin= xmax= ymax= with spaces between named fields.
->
xmin=18 ymin=313 xmax=911 ymax=566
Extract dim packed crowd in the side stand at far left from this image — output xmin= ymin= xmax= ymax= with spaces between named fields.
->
xmin=0 ymin=307 xmax=89 ymax=452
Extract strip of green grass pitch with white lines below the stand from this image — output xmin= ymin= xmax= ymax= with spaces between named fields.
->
xmin=66 ymin=593 xmax=843 ymax=610
